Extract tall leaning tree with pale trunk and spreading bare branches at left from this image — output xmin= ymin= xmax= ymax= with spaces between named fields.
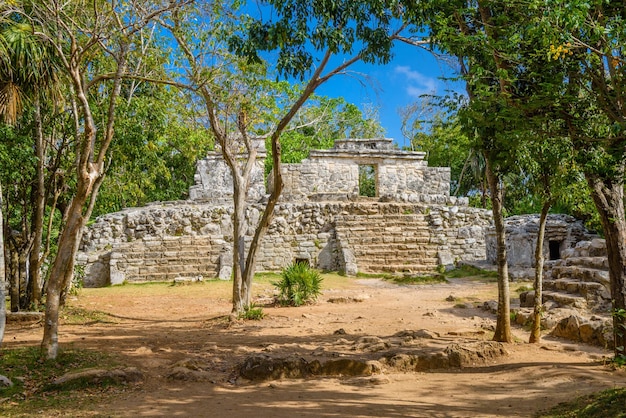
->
xmin=9 ymin=0 xmax=185 ymax=359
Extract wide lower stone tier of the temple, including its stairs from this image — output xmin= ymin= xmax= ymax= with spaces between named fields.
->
xmin=78 ymin=199 xmax=491 ymax=286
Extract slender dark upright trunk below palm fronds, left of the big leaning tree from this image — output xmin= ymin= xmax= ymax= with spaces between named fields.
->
xmin=27 ymin=97 xmax=46 ymax=310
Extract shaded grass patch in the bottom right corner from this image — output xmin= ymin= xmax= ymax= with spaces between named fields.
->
xmin=537 ymin=388 xmax=626 ymax=418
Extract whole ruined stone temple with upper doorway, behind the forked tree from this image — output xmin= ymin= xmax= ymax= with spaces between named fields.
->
xmin=78 ymin=139 xmax=491 ymax=286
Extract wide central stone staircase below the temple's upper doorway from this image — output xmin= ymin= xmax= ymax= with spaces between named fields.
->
xmin=335 ymin=214 xmax=438 ymax=274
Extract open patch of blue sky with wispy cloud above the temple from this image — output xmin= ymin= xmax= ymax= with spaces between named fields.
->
xmin=316 ymin=44 xmax=463 ymax=146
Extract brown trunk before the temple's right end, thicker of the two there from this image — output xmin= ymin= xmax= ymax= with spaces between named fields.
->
xmin=485 ymin=156 xmax=513 ymax=343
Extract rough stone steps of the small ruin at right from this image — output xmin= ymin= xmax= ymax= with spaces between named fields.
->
xmin=543 ymin=257 xmax=611 ymax=313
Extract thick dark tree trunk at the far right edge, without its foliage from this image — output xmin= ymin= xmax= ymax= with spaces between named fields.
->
xmin=585 ymin=173 xmax=626 ymax=357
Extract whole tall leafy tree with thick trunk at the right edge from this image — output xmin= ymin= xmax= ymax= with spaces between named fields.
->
xmin=539 ymin=1 xmax=626 ymax=359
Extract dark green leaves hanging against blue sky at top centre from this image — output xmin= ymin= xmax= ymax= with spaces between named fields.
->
xmin=229 ymin=0 xmax=401 ymax=79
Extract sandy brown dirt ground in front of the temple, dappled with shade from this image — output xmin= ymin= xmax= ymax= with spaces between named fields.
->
xmin=5 ymin=279 xmax=626 ymax=417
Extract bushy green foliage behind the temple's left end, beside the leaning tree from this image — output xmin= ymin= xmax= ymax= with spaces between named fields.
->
xmin=93 ymin=85 xmax=213 ymax=216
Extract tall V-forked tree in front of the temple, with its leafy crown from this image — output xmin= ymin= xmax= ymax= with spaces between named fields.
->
xmin=165 ymin=0 xmax=399 ymax=317
